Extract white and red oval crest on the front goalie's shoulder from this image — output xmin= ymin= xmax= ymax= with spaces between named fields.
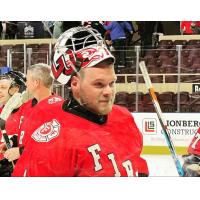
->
xmin=31 ymin=119 xmax=60 ymax=142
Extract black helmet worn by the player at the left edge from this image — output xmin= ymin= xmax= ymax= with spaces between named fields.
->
xmin=0 ymin=71 xmax=26 ymax=93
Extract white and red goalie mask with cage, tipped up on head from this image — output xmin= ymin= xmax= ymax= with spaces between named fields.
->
xmin=52 ymin=27 xmax=115 ymax=84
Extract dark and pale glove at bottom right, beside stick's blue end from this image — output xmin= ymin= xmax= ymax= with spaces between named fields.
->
xmin=183 ymin=154 xmax=200 ymax=177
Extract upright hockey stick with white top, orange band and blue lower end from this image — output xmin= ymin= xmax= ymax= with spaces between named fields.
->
xmin=139 ymin=61 xmax=184 ymax=176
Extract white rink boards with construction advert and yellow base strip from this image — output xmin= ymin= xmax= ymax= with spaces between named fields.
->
xmin=132 ymin=113 xmax=200 ymax=154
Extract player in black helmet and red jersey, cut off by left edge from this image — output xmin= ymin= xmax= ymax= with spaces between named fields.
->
xmin=0 ymin=71 xmax=26 ymax=176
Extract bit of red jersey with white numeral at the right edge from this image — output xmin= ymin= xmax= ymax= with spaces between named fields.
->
xmin=188 ymin=128 xmax=200 ymax=155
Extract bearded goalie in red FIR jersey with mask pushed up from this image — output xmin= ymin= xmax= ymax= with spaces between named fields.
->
xmin=13 ymin=27 xmax=148 ymax=177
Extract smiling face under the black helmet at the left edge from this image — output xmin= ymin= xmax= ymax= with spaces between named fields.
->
xmin=0 ymin=79 xmax=11 ymax=105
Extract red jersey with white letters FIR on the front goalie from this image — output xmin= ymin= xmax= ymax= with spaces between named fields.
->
xmin=13 ymin=101 xmax=148 ymax=177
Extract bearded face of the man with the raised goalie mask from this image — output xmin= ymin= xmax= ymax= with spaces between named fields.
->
xmin=72 ymin=66 xmax=116 ymax=115
